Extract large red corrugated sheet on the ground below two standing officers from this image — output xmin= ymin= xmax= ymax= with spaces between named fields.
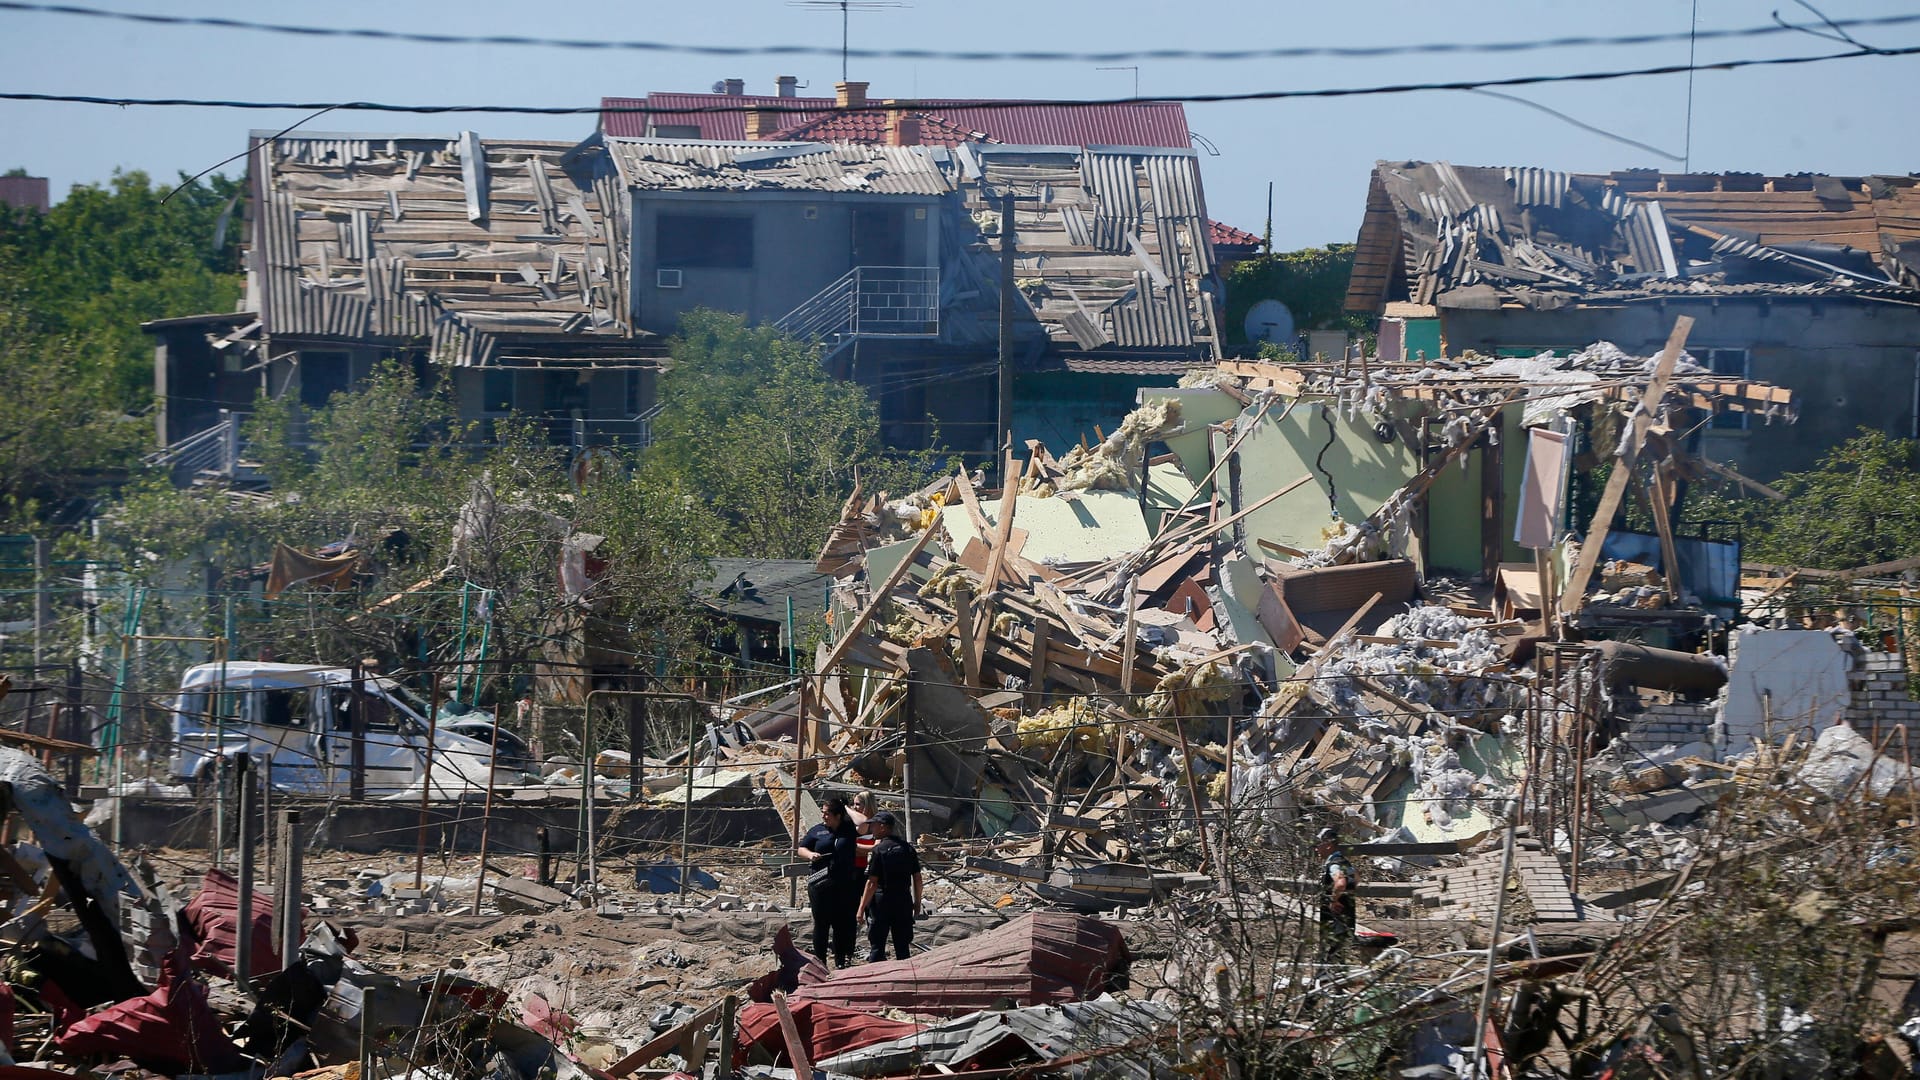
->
xmin=789 ymin=913 xmax=1131 ymax=1017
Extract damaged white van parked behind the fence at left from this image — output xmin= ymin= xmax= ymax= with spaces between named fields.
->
xmin=171 ymin=661 xmax=524 ymax=798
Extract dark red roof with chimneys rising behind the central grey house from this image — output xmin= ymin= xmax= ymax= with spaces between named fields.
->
xmin=601 ymin=92 xmax=1190 ymax=148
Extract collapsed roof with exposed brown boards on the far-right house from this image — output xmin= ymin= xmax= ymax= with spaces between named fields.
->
xmin=1346 ymin=161 xmax=1920 ymax=311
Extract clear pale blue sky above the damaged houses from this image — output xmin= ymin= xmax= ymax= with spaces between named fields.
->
xmin=0 ymin=0 xmax=1920 ymax=250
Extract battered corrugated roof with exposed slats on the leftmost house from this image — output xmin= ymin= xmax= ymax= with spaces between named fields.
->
xmin=250 ymin=135 xmax=630 ymax=365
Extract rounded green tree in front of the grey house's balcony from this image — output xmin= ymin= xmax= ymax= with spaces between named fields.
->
xmin=643 ymin=311 xmax=935 ymax=559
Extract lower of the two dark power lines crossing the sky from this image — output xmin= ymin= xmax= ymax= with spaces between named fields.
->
xmin=0 ymin=44 xmax=1920 ymax=115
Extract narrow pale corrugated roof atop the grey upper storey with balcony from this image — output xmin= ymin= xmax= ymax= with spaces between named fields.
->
xmin=607 ymin=138 xmax=954 ymax=196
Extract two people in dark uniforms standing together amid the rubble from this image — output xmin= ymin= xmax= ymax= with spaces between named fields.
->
xmin=793 ymin=792 xmax=925 ymax=967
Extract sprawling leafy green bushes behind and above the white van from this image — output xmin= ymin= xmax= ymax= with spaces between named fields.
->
xmin=100 ymin=365 xmax=716 ymax=707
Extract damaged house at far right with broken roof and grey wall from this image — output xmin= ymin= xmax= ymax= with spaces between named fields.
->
xmin=1346 ymin=161 xmax=1920 ymax=479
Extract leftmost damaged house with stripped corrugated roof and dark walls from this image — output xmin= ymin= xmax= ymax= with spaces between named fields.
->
xmin=144 ymin=131 xmax=662 ymax=477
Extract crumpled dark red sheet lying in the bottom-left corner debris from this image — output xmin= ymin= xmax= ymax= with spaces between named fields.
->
xmin=54 ymin=965 xmax=246 ymax=1076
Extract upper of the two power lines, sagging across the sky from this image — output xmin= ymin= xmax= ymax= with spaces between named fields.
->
xmin=0 ymin=0 xmax=1920 ymax=63
